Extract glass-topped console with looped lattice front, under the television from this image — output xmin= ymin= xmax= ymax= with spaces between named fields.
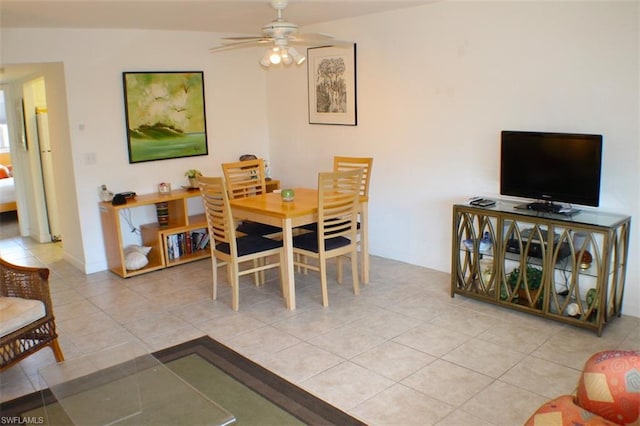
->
xmin=451 ymin=201 xmax=631 ymax=336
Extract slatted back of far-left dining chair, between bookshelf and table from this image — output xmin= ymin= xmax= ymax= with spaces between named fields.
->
xmin=222 ymin=158 xmax=267 ymax=199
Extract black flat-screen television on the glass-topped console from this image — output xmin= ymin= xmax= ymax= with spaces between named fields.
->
xmin=500 ymin=130 xmax=602 ymax=206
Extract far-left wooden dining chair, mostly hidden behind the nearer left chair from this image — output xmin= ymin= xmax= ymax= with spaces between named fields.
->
xmin=222 ymin=158 xmax=282 ymax=235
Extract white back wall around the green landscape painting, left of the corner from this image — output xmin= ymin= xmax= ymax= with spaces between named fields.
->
xmin=2 ymin=29 xmax=268 ymax=273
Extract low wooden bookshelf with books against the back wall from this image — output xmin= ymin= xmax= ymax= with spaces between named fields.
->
xmin=99 ymin=189 xmax=210 ymax=278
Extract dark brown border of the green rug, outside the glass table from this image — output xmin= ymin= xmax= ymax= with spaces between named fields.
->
xmin=0 ymin=336 xmax=366 ymax=425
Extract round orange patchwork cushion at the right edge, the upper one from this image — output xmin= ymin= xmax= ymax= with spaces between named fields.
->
xmin=576 ymin=350 xmax=640 ymax=425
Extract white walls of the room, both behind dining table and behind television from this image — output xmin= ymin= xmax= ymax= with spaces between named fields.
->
xmin=1 ymin=2 xmax=640 ymax=316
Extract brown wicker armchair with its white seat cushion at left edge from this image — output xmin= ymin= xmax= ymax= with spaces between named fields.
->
xmin=0 ymin=259 xmax=64 ymax=371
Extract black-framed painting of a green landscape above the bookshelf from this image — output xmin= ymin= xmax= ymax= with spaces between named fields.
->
xmin=122 ymin=71 xmax=209 ymax=164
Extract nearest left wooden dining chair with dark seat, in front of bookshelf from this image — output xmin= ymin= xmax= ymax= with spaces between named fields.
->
xmin=198 ymin=176 xmax=284 ymax=311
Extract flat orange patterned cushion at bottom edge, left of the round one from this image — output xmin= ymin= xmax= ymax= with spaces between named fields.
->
xmin=525 ymin=395 xmax=615 ymax=426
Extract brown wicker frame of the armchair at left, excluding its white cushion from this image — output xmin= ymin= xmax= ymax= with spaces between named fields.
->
xmin=0 ymin=259 xmax=64 ymax=372
